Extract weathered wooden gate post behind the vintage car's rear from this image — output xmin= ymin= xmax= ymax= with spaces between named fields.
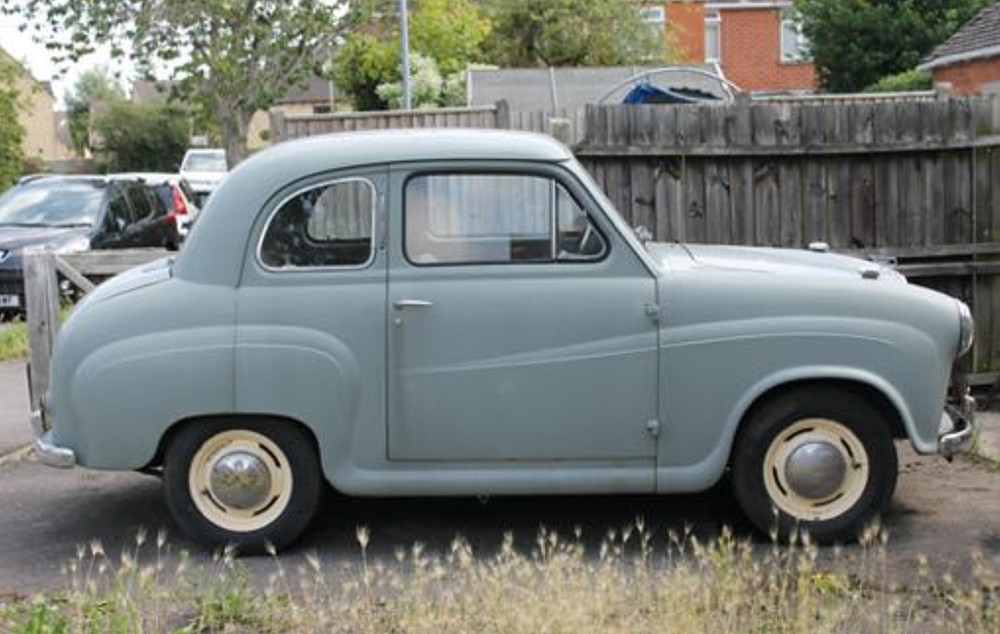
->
xmin=24 ymin=248 xmax=59 ymax=410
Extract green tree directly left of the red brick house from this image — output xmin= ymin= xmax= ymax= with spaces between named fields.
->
xmin=486 ymin=0 xmax=666 ymax=66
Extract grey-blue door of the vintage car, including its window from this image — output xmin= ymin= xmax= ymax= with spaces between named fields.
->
xmin=387 ymin=164 xmax=657 ymax=474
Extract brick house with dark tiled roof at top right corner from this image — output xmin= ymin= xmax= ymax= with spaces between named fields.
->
xmin=917 ymin=2 xmax=1000 ymax=95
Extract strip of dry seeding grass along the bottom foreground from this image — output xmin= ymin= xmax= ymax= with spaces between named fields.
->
xmin=0 ymin=521 xmax=1000 ymax=634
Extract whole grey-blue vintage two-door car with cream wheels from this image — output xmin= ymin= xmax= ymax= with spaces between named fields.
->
xmin=33 ymin=130 xmax=973 ymax=551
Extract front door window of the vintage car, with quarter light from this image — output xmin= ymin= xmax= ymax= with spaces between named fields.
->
xmin=404 ymin=173 xmax=607 ymax=264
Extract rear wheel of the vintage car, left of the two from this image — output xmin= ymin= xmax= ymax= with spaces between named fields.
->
xmin=164 ymin=419 xmax=323 ymax=554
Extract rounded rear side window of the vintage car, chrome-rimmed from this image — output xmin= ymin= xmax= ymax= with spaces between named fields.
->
xmin=259 ymin=178 xmax=375 ymax=269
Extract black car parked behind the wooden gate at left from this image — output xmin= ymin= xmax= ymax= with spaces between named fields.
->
xmin=0 ymin=175 xmax=181 ymax=317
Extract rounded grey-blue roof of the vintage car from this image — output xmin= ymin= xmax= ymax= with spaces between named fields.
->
xmin=174 ymin=128 xmax=572 ymax=285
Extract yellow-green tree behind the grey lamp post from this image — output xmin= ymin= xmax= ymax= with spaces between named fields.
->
xmin=333 ymin=0 xmax=490 ymax=110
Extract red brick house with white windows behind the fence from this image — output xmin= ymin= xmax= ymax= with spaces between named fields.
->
xmin=643 ymin=0 xmax=816 ymax=92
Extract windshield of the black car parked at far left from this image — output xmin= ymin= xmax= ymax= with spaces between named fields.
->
xmin=0 ymin=180 xmax=104 ymax=227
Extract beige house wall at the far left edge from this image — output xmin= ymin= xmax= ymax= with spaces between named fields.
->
xmin=0 ymin=48 xmax=72 ymax=162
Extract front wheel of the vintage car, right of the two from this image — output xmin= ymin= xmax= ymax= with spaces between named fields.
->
xmin=732 ymin=387 xmax=897 ymax=543
